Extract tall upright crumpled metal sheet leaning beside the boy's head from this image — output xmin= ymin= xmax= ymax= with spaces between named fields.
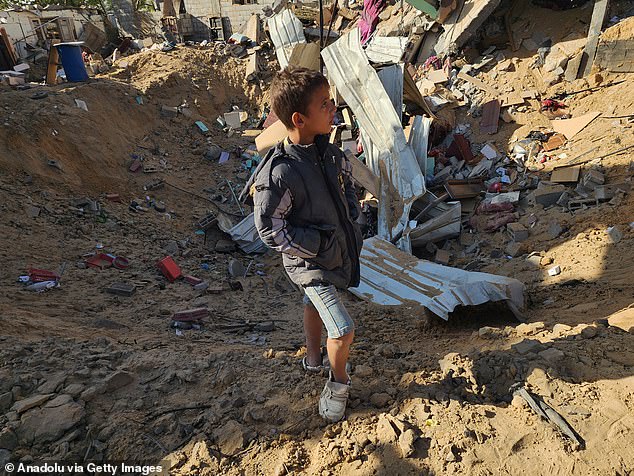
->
xmin=321 ymin=28 xmax=425 ymax=240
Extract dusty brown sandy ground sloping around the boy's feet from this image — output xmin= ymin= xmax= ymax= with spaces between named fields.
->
xmin=0 ymin=8 xmax=634 ymax=475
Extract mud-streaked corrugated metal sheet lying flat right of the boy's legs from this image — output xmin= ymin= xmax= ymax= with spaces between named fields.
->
xmin=350 ymin=236 xmax=524 ymax=320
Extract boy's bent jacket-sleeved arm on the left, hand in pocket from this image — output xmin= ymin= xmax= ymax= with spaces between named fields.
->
xmin=253 ymin=177 xmax=321 ymax=259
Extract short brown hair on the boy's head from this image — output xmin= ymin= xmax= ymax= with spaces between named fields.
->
xmin=270 ymin=66 xmax=330 ymax=129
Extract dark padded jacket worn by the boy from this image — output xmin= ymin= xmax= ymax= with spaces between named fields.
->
xmin=251 ymin=136 xmax=363 ymax=289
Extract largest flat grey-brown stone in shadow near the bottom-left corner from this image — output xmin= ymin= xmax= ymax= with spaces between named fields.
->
xmin=17 ymin=402 xmax=86 ymax=444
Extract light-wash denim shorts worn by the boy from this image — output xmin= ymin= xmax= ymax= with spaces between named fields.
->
xmin=304 ymin=285 xmax=354 ymax=339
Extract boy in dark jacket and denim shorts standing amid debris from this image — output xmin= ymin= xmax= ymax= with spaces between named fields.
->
xmin=248 ymin=68 xmax=363 ymax=422
